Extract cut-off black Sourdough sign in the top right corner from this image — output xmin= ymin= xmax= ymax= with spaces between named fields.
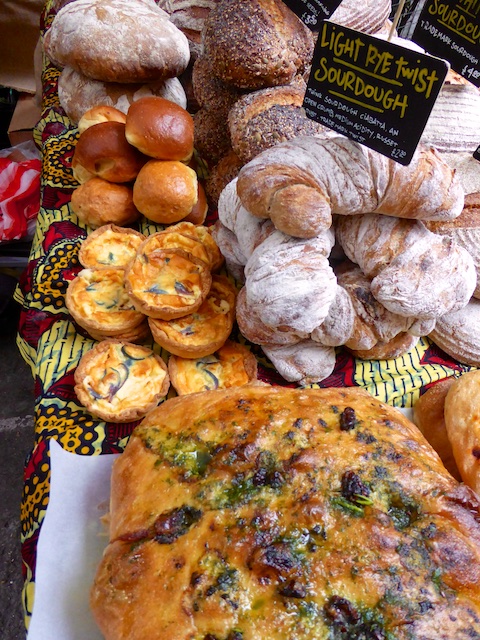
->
xmin=412 ymin=0 xmax=480 ymax=87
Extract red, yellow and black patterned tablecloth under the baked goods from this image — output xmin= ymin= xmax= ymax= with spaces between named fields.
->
xmin=16 ymin=0 xmax=468 ymax=627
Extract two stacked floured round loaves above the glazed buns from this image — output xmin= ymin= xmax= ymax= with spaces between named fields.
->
xmin=43 ymin=0 xmax=190 ymax=124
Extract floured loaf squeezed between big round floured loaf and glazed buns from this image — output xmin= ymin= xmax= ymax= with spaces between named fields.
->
xmin=58 ymin=66 xmax=187 ymax=123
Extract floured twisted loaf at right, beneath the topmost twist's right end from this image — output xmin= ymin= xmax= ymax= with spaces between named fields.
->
xmin=336 ymin=214 xmax=477 ymax=318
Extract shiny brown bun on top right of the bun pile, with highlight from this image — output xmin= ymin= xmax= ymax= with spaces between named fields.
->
xmin=125 ymin=96 xmax=193 ymax=162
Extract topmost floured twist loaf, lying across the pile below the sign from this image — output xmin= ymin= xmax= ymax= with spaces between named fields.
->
xmin=237 ymin=137 xmax=464 ymax=238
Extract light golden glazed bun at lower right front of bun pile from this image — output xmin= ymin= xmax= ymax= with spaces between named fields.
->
xmin=133 ymin=160 xmax=198 ymax=224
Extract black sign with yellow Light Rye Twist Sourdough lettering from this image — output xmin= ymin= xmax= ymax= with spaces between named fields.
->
xmin=303 ymin=21 xmax=449 ymax=165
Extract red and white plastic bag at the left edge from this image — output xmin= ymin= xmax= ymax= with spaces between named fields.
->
xmin=0 ymin=142 xmax=41 ymax=242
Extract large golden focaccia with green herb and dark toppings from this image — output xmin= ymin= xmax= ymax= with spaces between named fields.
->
xmin=91 ymin=386 xmax=480 ymax=640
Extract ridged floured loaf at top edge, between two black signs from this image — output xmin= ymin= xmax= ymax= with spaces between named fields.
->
xmin=329 ymin=0 xmax=392 ymax=34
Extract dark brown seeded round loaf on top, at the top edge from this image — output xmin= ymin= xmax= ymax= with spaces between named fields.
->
xmin=203 ymin=0 xmax=313 ymax=89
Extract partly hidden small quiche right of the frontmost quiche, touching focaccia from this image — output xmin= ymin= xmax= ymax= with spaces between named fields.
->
xmin=168 ymin=340 xmax=257 ymax=396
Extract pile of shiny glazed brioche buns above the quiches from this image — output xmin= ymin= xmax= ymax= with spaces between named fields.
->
xmin=71 ymin=96 xmax=207 ymax=229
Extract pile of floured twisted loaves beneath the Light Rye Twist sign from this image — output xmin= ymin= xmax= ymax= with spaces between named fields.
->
xmin=215 ymin=137 xmax=477 ymax=383
